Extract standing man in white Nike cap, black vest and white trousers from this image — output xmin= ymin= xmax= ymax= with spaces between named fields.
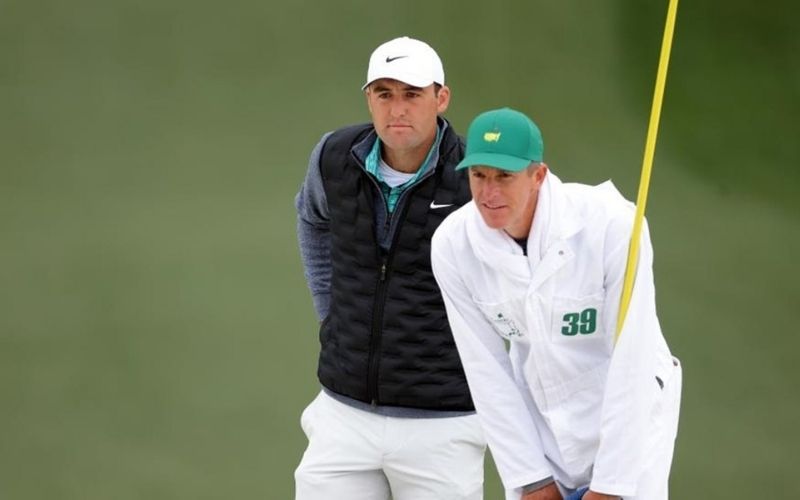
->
xmin=295 ymin=37 xmax=486 ymax=500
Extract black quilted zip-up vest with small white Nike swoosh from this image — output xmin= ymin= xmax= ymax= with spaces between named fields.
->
xmin=318 ymin=121 xmax=474 ymax=411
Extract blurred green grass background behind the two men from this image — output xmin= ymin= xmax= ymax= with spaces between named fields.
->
xmin=0 ymin=0 xmax=800 ymax=500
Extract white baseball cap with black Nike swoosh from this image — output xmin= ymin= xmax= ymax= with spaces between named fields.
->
xmin=361 ymin=36 xmax=444 ymax=90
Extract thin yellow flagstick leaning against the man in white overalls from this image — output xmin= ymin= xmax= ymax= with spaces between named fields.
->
xmin=614 ymin=0 xmax=678 ymax=343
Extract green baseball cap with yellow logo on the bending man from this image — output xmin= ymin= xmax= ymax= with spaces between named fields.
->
xmin=456 ymin=108 xmax=544 ymax=172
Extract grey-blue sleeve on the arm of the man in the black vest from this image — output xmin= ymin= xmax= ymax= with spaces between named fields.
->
xmin=294 ymin=133 xmax=332 ymax=320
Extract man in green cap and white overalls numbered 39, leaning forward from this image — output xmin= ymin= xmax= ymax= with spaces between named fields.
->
xmin=431 ymin=108 xmax=681 ymax=500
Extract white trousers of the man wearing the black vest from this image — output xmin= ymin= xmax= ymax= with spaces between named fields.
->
xmin=294 ymin=392 xmax=486 ymax=500
